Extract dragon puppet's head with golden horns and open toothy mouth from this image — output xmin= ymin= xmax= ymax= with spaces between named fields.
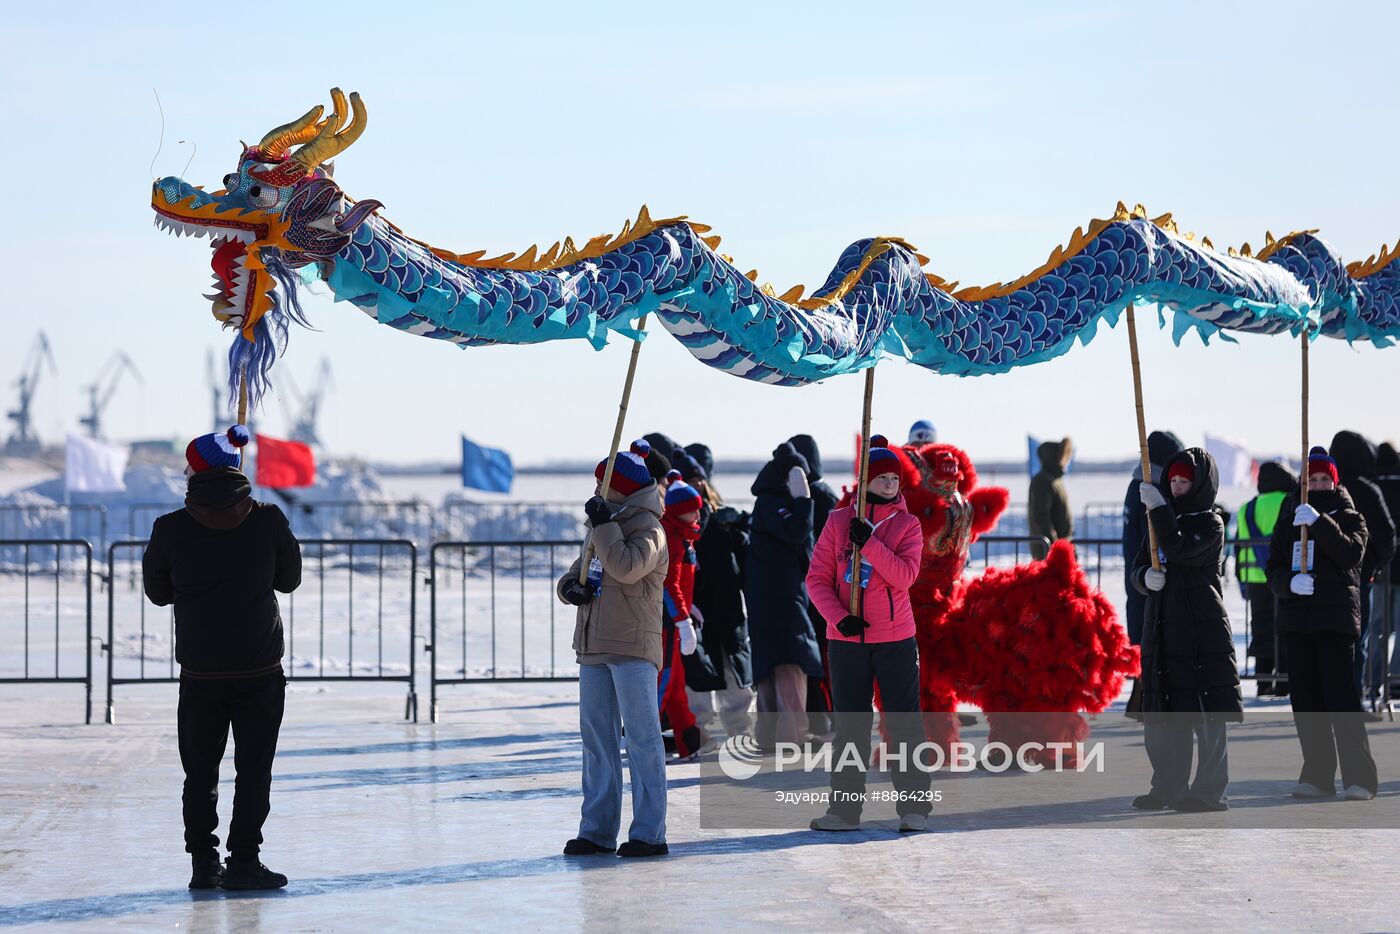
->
xmin=151 ymin=88 xmax=381 ymax=342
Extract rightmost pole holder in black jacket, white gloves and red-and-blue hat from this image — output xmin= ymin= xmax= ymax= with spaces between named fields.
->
xmin=1264 ymin=448 xmax=1379 ymax=801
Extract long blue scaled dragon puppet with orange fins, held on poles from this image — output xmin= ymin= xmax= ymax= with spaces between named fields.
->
xmin=151 ymin=88 xmax=1400 ymax=400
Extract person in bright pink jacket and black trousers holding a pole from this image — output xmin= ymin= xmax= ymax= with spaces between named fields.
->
xmin=806 ymin=435 xmax=931 ymax=832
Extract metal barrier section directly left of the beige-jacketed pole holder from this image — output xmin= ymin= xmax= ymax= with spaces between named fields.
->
xmin=426 ymin=541 xmax=579 ymax=723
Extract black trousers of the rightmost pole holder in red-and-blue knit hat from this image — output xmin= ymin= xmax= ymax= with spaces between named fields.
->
xmin=1284 ymin=633 xmax=1379 ymax=794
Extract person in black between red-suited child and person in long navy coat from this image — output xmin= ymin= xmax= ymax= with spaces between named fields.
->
xmin=676 ymin=444 xmax=753 ymax=737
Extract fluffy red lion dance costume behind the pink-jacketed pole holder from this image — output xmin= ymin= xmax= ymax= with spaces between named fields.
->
xmin=843 ymin=437 xmax=1138 ymax=766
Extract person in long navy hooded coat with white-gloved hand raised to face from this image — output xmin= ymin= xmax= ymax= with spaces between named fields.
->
xmin=743 ymin=441 xmax=823 ymax=746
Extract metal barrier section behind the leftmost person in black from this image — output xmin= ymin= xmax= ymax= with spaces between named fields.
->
xmin=106 ymin=538 xmax=419 ymax=723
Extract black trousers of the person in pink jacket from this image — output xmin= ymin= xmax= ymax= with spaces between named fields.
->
xmin=826 ymin=639 xmax=932 ymax=822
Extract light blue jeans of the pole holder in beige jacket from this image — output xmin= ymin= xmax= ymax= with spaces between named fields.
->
xmin=578 ymin=658 xmax=666 ymax=847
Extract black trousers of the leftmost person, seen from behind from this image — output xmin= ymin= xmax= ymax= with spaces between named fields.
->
xmin=179 ymin=671 xmax=287 ymax=860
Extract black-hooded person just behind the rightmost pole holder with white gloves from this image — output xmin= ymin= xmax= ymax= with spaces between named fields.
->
xmin=1327 ymin=431 xmax=1396 ymax=697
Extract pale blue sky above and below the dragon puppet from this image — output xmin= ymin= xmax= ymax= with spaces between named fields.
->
xmin=0 ymin=1 xmax=1400 ymax=462
